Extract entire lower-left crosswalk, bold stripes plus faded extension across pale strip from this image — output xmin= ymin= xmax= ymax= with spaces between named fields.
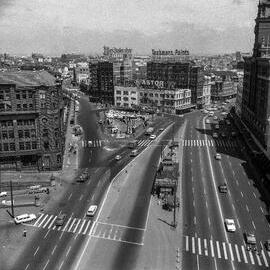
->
xmin=24 ymin=213 xmax=145 ymax=245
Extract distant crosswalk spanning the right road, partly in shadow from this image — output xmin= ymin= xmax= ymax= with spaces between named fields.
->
xmin=179 ymin=139 xmax=239 ymax=148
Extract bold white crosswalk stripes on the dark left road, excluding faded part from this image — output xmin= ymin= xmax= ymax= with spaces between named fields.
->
xmin=25 ymin=214 xmax=92 ymax=234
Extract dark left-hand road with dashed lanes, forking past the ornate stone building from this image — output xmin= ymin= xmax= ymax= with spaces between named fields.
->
xmin=12 ymin=99 xmax=174 ymax=270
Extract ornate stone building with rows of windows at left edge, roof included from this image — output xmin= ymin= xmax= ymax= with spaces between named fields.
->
xmin=0 ymin=71 xmax=64 ymax=170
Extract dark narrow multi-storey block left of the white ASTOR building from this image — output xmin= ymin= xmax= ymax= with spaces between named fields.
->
xmin=89 ymin=61 xmax=114 ymax=104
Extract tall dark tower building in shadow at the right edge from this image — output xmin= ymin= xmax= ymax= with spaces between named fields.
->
xmin=241 ymin=1 xmax=270 ymax=154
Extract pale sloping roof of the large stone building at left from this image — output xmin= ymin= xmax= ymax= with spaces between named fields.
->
xmin=0 ymin=71 xmax=55 ymax=86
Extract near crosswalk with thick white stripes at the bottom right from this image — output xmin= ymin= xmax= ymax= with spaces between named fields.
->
xmin=183 ymin=235 xmax=270 ymax=267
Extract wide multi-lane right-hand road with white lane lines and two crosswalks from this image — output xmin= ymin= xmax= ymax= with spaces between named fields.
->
xmin=182 ymin=108 xmax=270 ymax=270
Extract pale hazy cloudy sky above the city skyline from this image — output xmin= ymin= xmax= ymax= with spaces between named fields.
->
xmin=0 ymin=0 xmax=258 ymax=56
